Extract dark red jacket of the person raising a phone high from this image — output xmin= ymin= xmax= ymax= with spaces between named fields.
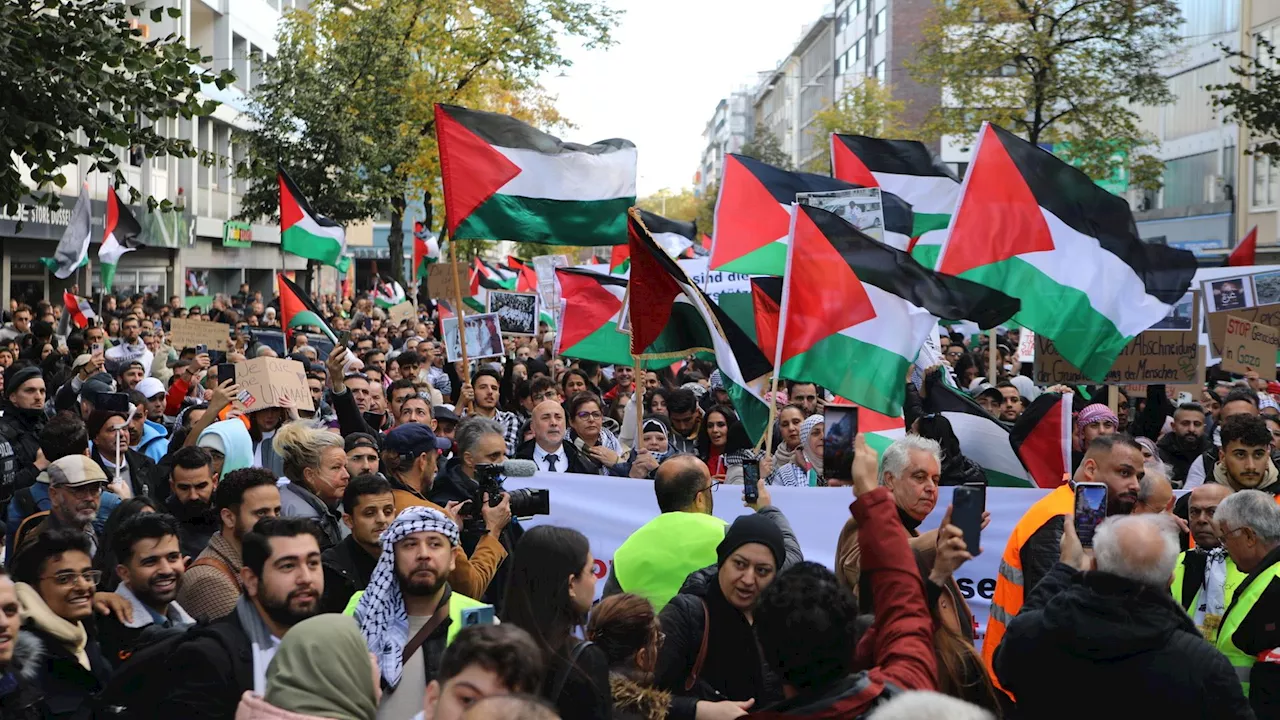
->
xmin=750 ymin=488 xmax=938 ymax=720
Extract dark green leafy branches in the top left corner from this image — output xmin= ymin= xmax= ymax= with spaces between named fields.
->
xmin=0 ymin=0 xmax=236 ymax=213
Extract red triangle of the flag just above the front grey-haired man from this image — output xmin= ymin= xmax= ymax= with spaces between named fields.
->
xmin=778 ymin=206 xmax=876 ymax=363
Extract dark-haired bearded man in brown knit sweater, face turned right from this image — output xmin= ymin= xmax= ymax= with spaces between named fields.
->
xmin=178 ymin=468 xmax=280 ymax=623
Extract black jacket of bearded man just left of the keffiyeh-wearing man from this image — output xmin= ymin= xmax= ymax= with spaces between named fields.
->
xmin=156 ymin=602 xmax=253 ymax=720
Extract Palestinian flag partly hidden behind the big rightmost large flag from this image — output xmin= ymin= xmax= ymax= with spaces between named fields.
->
xmin=831 ymin=133 xmax=960 ymax=269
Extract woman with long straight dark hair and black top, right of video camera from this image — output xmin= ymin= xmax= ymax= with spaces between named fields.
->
xmin=502 ymin=525 xmax=613 ymax=720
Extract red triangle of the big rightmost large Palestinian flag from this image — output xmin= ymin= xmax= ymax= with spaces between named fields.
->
xmin=938 ymin=124 xmax=1053 ymax=275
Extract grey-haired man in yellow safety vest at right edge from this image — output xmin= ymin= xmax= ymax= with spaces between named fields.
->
xmin=1213 ymin=489 xmax=1280 ymax=717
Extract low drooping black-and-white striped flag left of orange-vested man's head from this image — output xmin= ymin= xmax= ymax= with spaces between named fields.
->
xmin=922 ymin=373 xmax=1036 ymax=488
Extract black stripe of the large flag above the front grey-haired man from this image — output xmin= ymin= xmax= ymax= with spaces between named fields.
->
xmin=799 ymin=205 xmax=1023 ymax=329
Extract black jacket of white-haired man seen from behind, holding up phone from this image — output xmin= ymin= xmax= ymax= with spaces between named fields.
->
xmin=995 ymin=564 xmax=1254 ymax=720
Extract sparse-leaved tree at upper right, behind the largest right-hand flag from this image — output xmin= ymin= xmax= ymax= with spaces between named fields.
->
xmin=910 ymin=0 xmax=1183 ymax=187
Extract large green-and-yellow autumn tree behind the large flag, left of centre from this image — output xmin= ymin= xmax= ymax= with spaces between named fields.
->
xmin=238 ymin=0 xmax=616 ymax=279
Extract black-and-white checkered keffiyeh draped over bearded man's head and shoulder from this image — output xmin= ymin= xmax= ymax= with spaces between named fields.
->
xmin=356 ymin=507 xmax=458 ymax=688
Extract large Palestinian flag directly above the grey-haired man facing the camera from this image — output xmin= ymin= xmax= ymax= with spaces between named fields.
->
xmin=777 ymin=205 xmax=1018 ymax=416
